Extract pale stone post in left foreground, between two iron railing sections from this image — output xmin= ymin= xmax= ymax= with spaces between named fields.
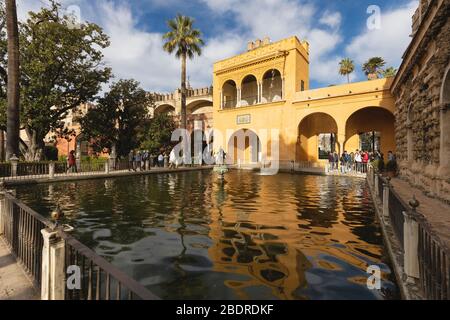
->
xmin=41 ymin=229 xmax=66 ymax=300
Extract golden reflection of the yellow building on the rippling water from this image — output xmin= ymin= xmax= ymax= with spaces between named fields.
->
xmin=208 ymin=174 xmax=381 ymax=299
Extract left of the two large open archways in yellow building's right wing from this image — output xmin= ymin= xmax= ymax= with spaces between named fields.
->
xmin=296 ymin=112 xmax=338 ymax=162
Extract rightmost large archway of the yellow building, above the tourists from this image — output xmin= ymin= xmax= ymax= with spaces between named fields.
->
xmin=342 ymin=107 xmax=396 ymax=156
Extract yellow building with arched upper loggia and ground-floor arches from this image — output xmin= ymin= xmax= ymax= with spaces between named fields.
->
xmin=213 ymin=37 xmax=395 ymax=167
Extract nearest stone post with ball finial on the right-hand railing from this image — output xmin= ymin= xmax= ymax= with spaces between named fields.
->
xmin=403 ymin=197 xmax=420 ymax=283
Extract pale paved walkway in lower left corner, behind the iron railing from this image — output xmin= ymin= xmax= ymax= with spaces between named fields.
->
xmin=0 ymin=236 xmax=39 ymax=300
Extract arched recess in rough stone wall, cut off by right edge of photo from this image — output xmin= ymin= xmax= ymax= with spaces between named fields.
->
xmin=438 ymin=64 xmax=450 ymax=178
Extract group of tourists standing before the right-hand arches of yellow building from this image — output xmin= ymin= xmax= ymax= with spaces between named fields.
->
xmin=328 ymin=150 xmax=383 ymax=174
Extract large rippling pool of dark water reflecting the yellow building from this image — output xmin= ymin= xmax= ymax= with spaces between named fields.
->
xmin=16 ymin=171 xmax=398 ymax=299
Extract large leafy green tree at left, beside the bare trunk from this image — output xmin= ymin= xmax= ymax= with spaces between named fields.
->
xmin=6 ymin=1 xmax=111 ymax=161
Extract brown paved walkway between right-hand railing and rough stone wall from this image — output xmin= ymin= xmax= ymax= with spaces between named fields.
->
xmin=391 ymin=179 xmax=450 ymax=248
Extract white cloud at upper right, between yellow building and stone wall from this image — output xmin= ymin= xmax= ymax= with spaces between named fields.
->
xmin=346 ymin=1 xmax=418 ymax=66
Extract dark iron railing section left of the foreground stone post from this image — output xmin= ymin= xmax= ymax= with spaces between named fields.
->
xmin=0 ymin=192 xmax=53 ymax=288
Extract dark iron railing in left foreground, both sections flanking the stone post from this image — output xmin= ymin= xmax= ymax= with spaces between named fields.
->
xmin=0 ymin=191 xmax=159 ymax=300
